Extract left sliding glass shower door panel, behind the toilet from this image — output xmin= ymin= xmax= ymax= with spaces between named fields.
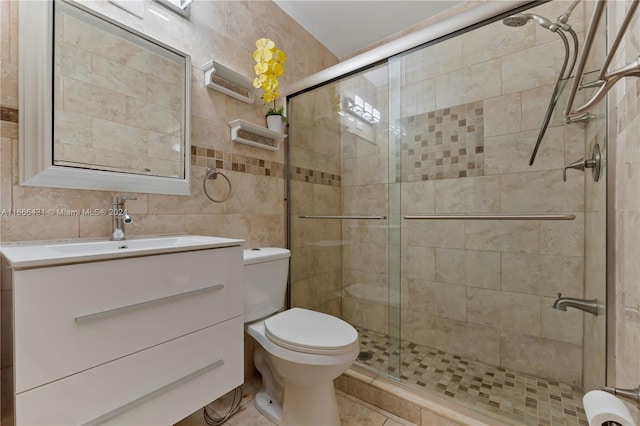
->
xmin=289 ymin=64 xmax=399 ymax=371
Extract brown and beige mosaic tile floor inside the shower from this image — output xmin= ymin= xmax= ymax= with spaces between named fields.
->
xmin=356 ymin=327 xmax=588 ymax=426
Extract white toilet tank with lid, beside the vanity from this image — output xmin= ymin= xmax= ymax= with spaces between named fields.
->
xmin=243 ymin=247 xmax=291 ymax=322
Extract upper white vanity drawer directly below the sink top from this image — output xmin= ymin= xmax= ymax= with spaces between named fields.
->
xmin=13 ymin=246 xmax=243 ymax=393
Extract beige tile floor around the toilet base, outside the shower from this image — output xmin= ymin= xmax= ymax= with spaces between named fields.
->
xmin=175 ymin=375 xmax=414 ymax=426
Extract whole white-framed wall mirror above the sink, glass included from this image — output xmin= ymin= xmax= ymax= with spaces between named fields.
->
xmin=19 ymin=0 xmax=191 ymax=195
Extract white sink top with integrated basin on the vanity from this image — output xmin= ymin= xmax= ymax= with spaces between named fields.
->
xmin=0 ymin=235 xmax=244 ymax=268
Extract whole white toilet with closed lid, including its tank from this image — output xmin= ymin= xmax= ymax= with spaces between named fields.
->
xmin=244 ymin=247 xmax=359 ymax=426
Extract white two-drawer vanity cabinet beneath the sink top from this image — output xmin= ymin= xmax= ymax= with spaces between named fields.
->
xmin=3 ymin=241 xmax=244 ymax=425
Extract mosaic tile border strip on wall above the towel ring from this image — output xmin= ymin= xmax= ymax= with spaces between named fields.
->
xmin=191 ymin=145 xmax=285 ymax=179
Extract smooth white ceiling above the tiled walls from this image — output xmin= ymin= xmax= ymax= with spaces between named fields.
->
xmin=274 ymin=0 xmax=462 ymax=58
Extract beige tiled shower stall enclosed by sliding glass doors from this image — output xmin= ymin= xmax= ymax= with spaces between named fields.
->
xmin=287 ymin=1 xmax=607 ymax=424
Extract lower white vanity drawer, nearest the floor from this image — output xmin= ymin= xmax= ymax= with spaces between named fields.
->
xmin=16 ymin=317 xmax=244 ymax=426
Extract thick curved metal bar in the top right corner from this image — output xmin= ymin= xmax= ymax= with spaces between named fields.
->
xmin=564 ymin=0 xmax=640 ymax=122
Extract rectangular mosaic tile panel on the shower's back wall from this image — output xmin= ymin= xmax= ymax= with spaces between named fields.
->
xmin=401 ymin=101 xmax=484 ymax=182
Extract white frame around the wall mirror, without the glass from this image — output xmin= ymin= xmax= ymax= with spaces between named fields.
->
xmin=18 ymin=0 xmax=191 ymax=195
